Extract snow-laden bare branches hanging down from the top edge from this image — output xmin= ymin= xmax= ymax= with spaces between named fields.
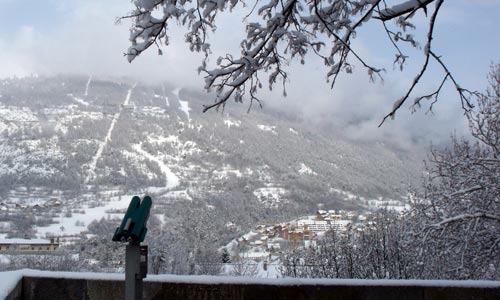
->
xmin=123 ymin=0 xmax=464 ymax=120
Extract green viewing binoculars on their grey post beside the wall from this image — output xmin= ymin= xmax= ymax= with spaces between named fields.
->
xmin=113 ymin=196 xmax=152 ymax=300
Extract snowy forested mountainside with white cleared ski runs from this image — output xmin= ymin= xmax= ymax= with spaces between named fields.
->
xmin=0 ymin=76 xmax=420 ymax=227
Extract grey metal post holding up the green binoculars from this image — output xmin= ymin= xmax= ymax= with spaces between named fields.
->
xmin=125 ymin=243 xmax=143 ymax=300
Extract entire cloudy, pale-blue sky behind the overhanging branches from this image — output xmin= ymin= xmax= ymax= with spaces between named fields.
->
xmin=0 ymin=0 xmax=500 ymax=150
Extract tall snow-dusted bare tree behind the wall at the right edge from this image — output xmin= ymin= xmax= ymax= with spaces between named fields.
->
xmin=412 ymin=64 xmax=500 ymax=279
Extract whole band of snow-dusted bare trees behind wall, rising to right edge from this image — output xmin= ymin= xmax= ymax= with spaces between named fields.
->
xmin=283 ymin=64 xmax=500 ymax=280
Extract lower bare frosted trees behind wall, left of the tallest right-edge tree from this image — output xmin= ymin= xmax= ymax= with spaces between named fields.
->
xmin=281 ymin=209 xmax=414 ymax=279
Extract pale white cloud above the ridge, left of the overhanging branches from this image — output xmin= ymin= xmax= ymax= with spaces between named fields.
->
xmin=0 ymin=1 xmax=203 ymax=86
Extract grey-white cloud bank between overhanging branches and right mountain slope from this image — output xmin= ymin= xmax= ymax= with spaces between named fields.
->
xmin=260 ymin=45 xmax=468 ymax=149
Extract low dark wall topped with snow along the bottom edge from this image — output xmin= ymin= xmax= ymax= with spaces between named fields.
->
xmin=0 ymin=270 xmax=500 ymax=300
